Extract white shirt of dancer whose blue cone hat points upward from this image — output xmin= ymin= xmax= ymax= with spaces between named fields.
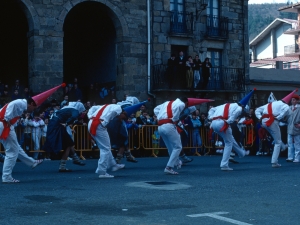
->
xmin=208 ymin=103 xmax=243 ymax=124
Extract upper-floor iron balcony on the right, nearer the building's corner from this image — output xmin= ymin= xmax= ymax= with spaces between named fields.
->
xmin=205 ymin=15 xmax=228 ymax=39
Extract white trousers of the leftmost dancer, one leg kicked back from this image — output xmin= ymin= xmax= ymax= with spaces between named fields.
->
xmin=0 ymin=129 xmax=35 ymax=181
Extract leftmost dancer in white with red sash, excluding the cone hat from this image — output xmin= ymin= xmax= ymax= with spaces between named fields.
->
xmin=0 ymin=99 xmax=43 ymax=183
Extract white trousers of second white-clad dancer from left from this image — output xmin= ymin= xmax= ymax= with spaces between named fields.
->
xmin=88 ymin=120 xmax=117 ymax=175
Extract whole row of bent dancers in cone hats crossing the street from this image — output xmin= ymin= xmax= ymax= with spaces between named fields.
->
xmin=0 ymin=84 xmax=300 ymax=183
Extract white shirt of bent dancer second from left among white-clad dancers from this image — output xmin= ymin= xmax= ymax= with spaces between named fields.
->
xmin=87 ymin=104 xmax=122 ymax=127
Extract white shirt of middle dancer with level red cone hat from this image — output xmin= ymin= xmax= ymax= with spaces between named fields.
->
xmin=154 ymin=98 xmax=185 ymax=122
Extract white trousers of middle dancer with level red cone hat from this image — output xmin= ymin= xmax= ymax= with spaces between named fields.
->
xmin=158 ymin=123 xmax=182 ymax=168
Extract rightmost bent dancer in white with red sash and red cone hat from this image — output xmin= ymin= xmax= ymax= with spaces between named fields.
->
xmin=255 ymin=90 xmax=298 ymax=168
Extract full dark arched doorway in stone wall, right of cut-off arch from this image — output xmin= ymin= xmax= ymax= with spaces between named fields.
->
xmin=63 ymin=1 xmax=120 ymax=99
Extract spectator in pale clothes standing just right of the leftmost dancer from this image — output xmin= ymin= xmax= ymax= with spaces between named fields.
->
xmin=29 ymin=111 xmax=45 ymax=159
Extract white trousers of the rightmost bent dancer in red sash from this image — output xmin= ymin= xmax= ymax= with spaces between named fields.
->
xmin=261 ymin=118 xmax=284 ymax=163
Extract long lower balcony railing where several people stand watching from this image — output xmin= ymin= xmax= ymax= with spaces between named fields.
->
xmin=151 ymin=65 xmax=245 ymax=92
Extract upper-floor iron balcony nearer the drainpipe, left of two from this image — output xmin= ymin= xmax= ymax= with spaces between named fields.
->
xmin=170 ymin=11 xmax=194 ymax=35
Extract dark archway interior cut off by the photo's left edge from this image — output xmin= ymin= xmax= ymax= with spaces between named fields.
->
xmin=0 ymin=0 xmax=29 ymax=87
